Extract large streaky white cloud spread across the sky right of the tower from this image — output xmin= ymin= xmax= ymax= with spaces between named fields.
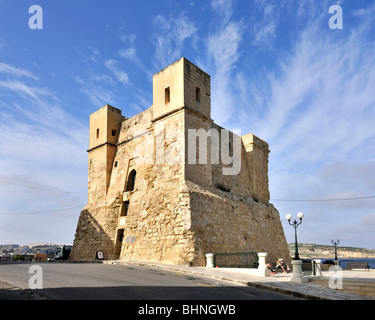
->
xmin=234 ymin=1 xmax=375 ymax=242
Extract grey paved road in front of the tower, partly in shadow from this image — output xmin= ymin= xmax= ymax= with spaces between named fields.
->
xmin=0 ymin=262 xmax=302 ymax=300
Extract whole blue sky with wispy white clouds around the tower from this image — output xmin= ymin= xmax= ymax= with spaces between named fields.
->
xmin=0 ymin=0 xmax=375 ymax=248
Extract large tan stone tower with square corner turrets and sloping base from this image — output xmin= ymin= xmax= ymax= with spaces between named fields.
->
xmin=71 ymin=58 xmax=290 ymax=265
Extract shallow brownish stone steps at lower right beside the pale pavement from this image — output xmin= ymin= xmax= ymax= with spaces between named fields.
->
xmin=310 ymin=277 xmax=375 ymax=299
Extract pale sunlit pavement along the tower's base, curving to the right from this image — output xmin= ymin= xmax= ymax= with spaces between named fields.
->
xmin=103 ymin=260 xmax=375 ymax=300
